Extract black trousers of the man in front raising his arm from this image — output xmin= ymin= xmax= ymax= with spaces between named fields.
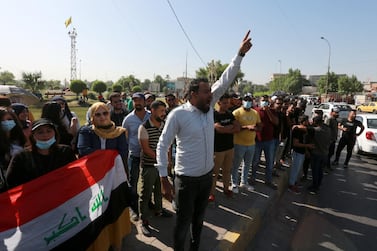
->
xmin=174 ymin=171 xmax=212 ymax=250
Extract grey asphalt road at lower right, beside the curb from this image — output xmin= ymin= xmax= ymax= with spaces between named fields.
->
xmin=248 ymin=150 xmax=377 ymax=250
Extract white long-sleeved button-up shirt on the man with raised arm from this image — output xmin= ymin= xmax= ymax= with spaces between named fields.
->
xmin=156 ymin=55 xmax=242 ymax=177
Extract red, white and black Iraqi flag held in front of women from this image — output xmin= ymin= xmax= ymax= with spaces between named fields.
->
xmin=0 ymin=150 xmax=131 ymax=251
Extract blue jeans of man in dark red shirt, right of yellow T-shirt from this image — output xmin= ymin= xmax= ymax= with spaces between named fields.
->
xmin=252 ymin=139 xmax=275 ymax=182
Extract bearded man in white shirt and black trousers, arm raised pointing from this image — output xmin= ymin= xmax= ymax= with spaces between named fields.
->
xmin=156 ymin=31 xmax=252 ymax=250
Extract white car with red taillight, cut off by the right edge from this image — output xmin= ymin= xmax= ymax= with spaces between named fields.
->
xmin=353 ymin=113 xmax=377 ymax=154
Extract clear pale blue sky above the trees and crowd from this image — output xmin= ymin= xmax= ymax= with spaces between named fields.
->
xmin=0 ymin=0 xmax=377 ymax=84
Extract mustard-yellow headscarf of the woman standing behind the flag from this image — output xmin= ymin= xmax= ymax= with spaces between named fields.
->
xmin=89 ymin=102 xmax=126 ymax=139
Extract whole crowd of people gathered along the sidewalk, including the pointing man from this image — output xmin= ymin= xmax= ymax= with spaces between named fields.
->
xmin=0 ymin=29 xmax=363 ymax=250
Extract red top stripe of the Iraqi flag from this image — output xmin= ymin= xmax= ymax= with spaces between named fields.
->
xmin=0 ymin=150 xmax=118 ymax=232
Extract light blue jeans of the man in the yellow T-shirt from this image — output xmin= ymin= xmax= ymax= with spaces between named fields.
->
xmin=232 ymin=145 xmax=255 ymax=186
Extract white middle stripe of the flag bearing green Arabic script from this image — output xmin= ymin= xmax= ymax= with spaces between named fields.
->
xmin=0 ymin=155 xmax=127 ymax=250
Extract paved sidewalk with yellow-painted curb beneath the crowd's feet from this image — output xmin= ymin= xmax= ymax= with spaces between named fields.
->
xmin=122 ymin=164 xmax=289 ymax=251
